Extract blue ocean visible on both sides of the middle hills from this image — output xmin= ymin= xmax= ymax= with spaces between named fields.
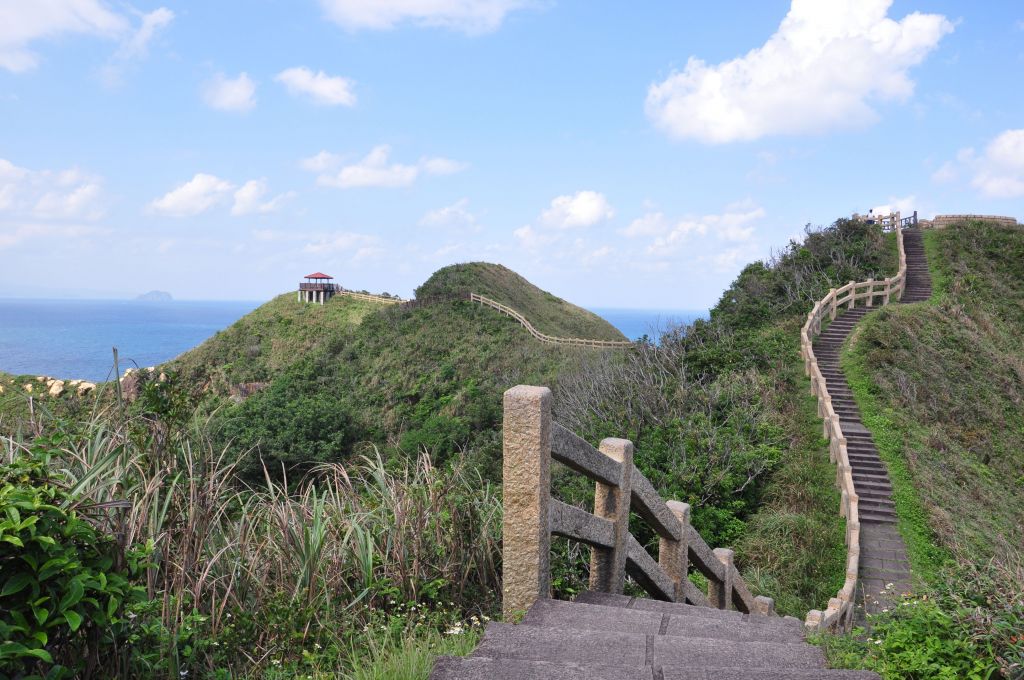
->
xmin=0 ymin=299 xmax=707 ymax=382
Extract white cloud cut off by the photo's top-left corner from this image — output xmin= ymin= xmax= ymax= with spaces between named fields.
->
xmin=0 ymin=0 xmax=129 ymax=73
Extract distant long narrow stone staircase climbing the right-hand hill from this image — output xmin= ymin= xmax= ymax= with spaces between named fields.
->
xmin=814 ymin=229 xmax=932 ymax=613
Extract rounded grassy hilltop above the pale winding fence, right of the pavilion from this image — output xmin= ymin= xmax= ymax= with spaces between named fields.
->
xmin=416 ymin=262 xmax=626 ymax=340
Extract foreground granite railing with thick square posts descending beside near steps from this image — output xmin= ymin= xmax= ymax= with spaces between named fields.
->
xmin=502 ymin=385 xmax=774 ymax=620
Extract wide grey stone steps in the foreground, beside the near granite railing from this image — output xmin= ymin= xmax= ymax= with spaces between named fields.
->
xmin=430 ymin=592 xmax=879 ymax=680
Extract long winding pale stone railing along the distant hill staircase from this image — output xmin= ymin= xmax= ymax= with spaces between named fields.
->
xmin=800 ymin=213 xmax=916 ymax=630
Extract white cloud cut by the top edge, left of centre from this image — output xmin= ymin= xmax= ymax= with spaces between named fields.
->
xmin=321 ymin=0 xmax=530 ymax=34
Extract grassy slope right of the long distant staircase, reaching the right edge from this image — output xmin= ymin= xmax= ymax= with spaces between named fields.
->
xmin=815 ymin=222 xmax=1024 ymax=678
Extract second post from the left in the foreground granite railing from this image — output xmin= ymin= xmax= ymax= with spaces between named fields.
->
xmin=590 ymin=438 xmax=633 ymax=593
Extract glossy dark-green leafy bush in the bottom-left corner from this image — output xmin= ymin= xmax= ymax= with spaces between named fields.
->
xmin=0 ymin=441 xmax=143 ymax=678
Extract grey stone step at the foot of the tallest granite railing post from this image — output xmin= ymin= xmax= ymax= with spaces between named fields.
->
xmin=520 ymin=599 xmax=804 ymax=642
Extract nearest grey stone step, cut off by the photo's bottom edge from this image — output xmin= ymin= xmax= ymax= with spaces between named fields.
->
xmin=430 ymin=656 xmax=880 ymax=680
